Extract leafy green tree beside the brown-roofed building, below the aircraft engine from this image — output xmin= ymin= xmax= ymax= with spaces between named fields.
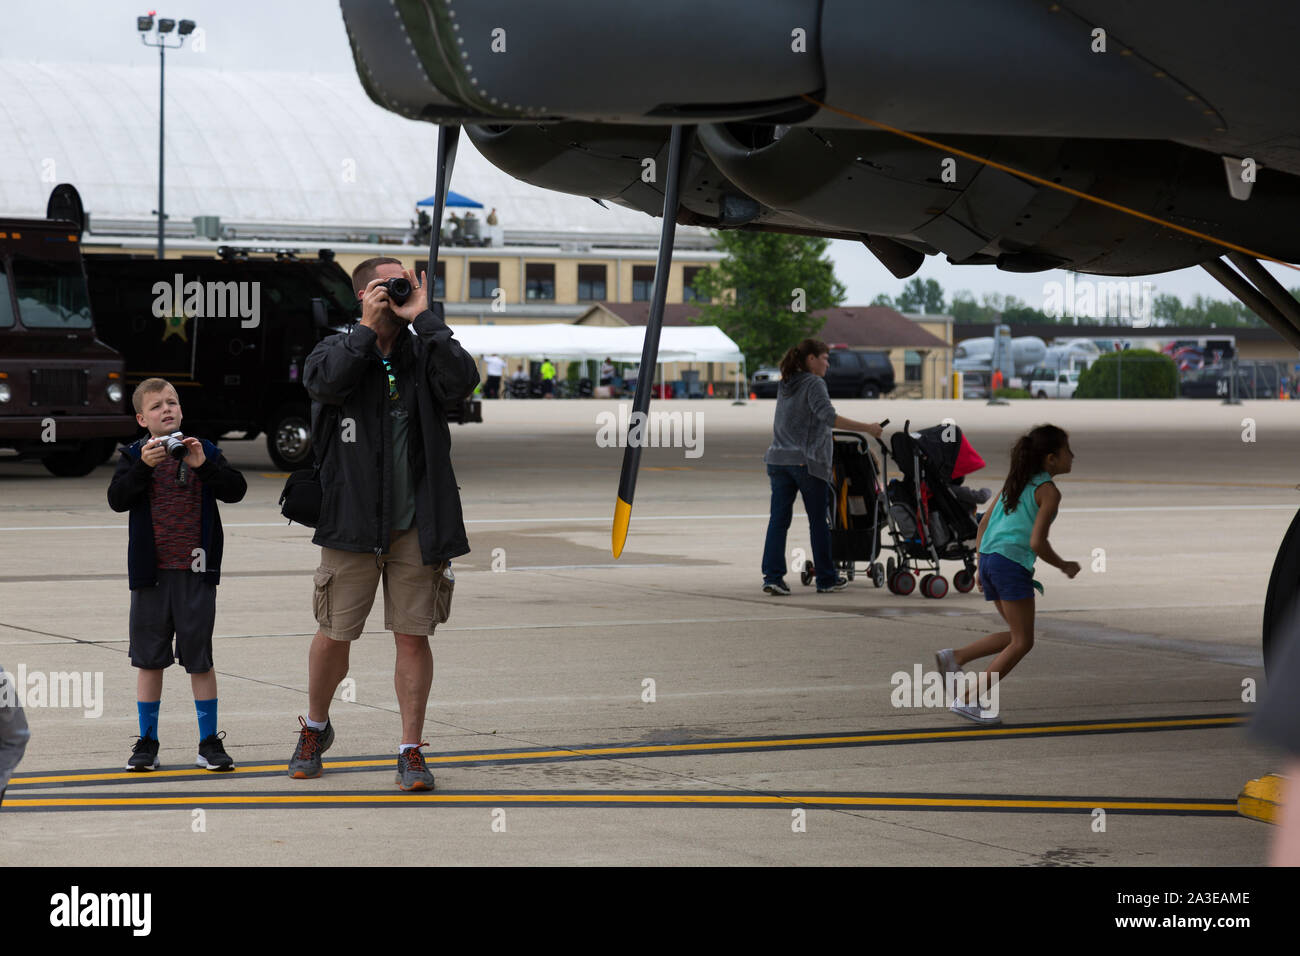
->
xmin=694 ymin=230 xmax=845 ymax=367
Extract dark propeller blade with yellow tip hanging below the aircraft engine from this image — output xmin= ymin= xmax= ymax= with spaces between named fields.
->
xmin=612 ymin=125 xmax=686 ymax=559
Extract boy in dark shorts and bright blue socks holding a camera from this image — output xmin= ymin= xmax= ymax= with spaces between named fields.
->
xmin=108 ymin=378 xmax=248 ymax=771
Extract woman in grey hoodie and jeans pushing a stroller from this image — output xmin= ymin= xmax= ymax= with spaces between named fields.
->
xmin=763 ymin=338 xmax=880 ymax=596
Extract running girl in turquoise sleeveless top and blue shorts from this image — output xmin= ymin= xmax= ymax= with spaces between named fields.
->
xmin=935 ymin=425 xmax=1079 ymax=723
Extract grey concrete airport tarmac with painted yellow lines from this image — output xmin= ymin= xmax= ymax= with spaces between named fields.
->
xmin=0 ymin=399 xmax=1300 ymax=866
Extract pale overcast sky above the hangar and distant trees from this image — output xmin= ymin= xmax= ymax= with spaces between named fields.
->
xmin=0 ymin=0 xmax=1300 ymax=308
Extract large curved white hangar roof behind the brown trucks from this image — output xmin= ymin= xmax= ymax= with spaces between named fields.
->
xmin=0 ymin=58 xmax=706 ymax=246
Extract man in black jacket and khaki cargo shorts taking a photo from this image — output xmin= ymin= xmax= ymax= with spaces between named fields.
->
xmin=289 ymin=258 xmax=478 ymax=790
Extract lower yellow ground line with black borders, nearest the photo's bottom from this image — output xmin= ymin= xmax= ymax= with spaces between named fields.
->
xmin=5 ymin=793 xmax=1236 ymax=814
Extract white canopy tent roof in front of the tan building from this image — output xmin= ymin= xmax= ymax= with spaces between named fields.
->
xmin=451 ymin=324 xmax=744 ymax=364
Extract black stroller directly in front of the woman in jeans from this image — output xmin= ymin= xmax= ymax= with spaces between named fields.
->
xmin=800 ymin=432 xmax=888 ymax=588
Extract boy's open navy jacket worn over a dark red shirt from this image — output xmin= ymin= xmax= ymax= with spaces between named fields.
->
xmin=108 ymin=434 xmax=248 ymax=591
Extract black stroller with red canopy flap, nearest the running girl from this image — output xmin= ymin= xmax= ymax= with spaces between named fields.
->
xmin=881 ymin=423 xmax=984 ymax=598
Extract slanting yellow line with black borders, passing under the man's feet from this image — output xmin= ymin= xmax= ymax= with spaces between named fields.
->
xmin=9 ymin=717 xmax=1247 ymax=787
